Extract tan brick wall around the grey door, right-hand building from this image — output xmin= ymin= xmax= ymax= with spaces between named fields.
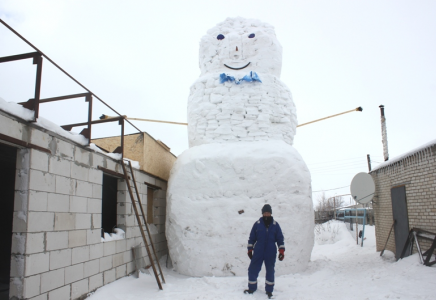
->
xmin=370 ymin=145 xmax=436 ymax=253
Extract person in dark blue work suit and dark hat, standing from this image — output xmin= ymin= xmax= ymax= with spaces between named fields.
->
xmin=244 ymin=204 xmax=285 ymax=298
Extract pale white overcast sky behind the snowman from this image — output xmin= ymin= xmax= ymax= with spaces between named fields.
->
xmin=0 ymin=0 xmax=436 ymax=205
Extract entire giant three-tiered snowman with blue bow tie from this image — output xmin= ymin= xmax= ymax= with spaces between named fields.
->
xmin=166 ymin=17 xmax=314 ymax=276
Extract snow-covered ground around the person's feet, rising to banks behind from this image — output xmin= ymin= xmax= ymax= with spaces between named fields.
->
xmin=87 ymin=221 xmax=436 ymax=300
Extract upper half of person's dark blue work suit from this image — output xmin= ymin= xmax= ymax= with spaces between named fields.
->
xmin=247 ymin=218 xmax=285 ymax=259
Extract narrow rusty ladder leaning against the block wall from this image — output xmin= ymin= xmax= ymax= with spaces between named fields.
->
xmin=121 ymin=160 xmax=165 ymax=290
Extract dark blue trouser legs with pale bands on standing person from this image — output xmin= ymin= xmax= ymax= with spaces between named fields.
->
xmin=248 ymin=255 xmax=276 ymax=293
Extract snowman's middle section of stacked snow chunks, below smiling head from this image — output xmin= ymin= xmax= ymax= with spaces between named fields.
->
xmin=188 ymin=70 xmax=297 ymax=147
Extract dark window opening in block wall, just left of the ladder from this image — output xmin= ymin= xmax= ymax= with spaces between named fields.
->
xmin=101 ymin=174 xmax=118 ymax=237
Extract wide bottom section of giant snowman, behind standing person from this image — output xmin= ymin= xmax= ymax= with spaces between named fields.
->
xmin=166 ymin=141 xmax=314 ymax=276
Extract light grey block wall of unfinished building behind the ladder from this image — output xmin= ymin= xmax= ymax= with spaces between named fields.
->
xmin=0 ymin=114 xmax=168 ymax=300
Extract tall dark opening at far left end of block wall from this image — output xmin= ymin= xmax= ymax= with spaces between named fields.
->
xmin=0 ymin=144 xmax=17 ymax=300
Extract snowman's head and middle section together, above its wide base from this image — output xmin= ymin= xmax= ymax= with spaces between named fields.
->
xmin=188 ymin=18 xmax=297 ymax=147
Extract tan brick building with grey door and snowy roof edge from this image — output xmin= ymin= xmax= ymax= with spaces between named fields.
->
xmin=370 ymin=140 xmax=436 ymax=258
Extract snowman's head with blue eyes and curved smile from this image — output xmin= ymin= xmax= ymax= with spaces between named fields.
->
xmin=199 ymin=17 xmax=282 ymax=77
